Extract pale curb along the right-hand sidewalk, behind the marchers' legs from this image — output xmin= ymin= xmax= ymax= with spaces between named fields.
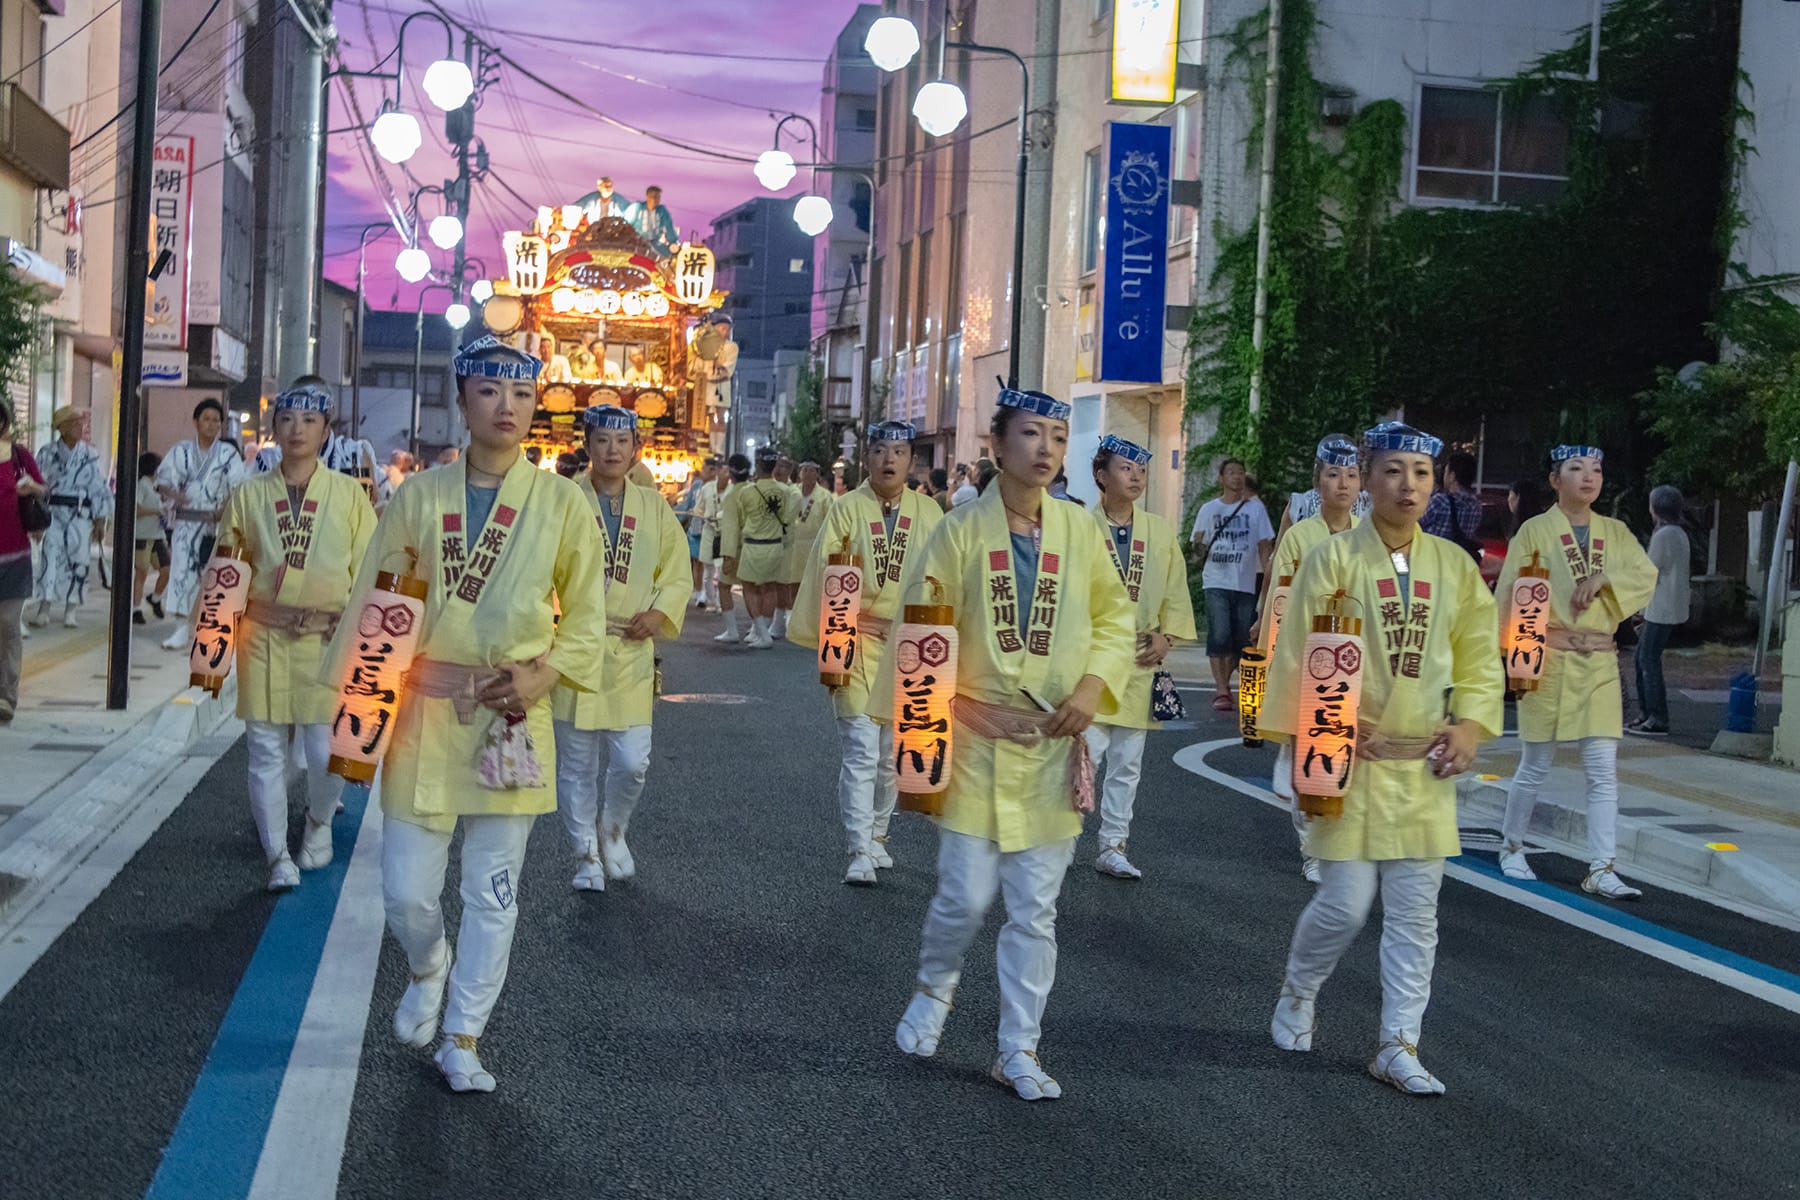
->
xmin=1456 ymin=775 xmax=1800 ymax=918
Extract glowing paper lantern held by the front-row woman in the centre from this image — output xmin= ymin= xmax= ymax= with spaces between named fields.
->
xmin=891 ymin=604 xmax=956 ymax=815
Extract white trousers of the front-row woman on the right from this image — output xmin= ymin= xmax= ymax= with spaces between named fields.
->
xmin=1287 ymin=858 xmax=1444 ymax=1045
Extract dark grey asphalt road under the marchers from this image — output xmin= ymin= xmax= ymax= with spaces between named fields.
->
xmin=0 ymin=617 xmax=1800 ymax=1200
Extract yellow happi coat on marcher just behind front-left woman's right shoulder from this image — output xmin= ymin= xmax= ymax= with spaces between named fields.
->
xmin=551 ymin=475 xmax=693 ymax=729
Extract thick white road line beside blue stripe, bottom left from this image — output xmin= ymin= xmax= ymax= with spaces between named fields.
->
xmin=248 ymin=790 xmax=385 ymax=1200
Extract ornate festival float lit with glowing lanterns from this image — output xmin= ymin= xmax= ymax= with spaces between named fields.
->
xmin=482 ymin=205 xmax=725 ymax=497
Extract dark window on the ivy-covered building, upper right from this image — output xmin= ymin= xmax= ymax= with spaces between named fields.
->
xmin=1413 ymin=86 xmax=1570 ymax=205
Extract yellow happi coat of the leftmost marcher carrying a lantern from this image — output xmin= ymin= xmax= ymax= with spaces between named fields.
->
xmin=218 ymin=464 xmax=374 ymax=725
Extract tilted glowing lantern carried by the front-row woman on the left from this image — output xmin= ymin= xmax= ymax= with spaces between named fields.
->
xmin=329 ymin=570 xmax=427 ymax=783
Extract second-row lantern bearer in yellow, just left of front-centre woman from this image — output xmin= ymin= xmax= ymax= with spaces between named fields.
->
xmin=788 ymin=421 xmax=943 ymax=885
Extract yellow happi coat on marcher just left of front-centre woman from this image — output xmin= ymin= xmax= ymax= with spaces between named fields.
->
xmin=788 ymin=482 xmax=943 ymax=718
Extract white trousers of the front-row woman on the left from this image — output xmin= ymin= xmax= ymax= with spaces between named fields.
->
xmin=382 ymin=817 xmax=535 ymax=1038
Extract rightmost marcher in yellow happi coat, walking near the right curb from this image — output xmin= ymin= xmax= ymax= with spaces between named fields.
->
xmin=1494 ymin=446 xmax=1656 ymax=900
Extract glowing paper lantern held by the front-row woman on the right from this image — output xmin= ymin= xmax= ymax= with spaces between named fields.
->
xmin=1294 ymin=592 xmax=1364 ymax=817
